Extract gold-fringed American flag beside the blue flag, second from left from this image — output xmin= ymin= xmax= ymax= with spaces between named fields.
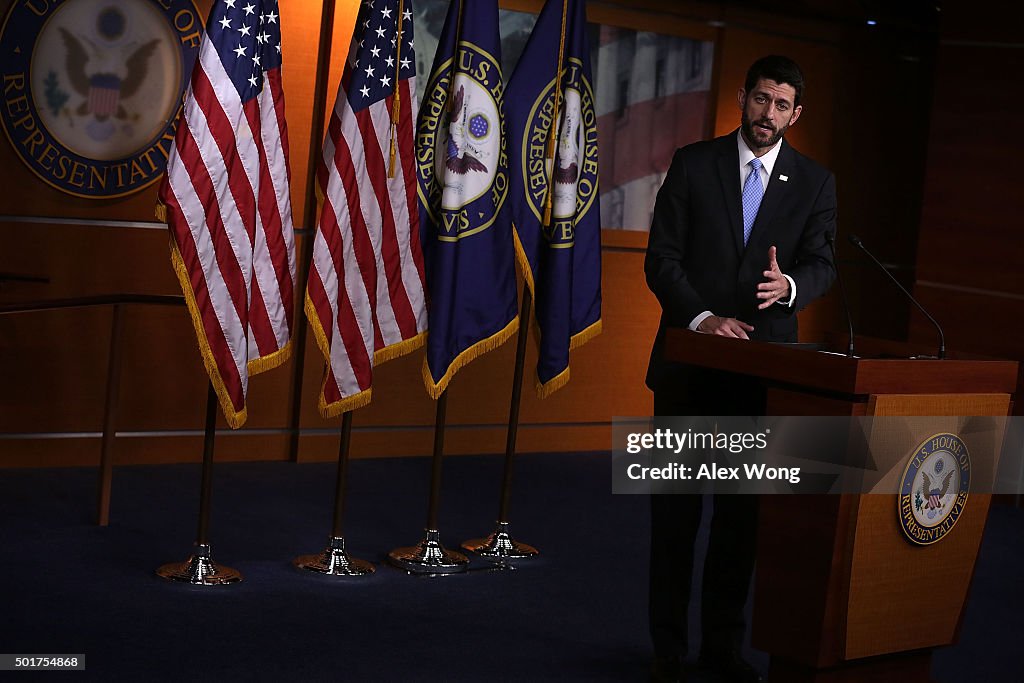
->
xmin=306 ymin=0 xmax=427 ymax=417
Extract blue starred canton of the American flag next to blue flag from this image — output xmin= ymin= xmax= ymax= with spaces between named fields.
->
xmin=348 ymin=0 xmax=416 ymax=110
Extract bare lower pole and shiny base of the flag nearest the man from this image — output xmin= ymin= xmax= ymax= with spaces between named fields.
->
xmin=462 ymin=283 xmax=540 ymax=560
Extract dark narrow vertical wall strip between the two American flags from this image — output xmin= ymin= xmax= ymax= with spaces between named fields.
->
xmin=288 ymin=0 xmax=335 ymax=463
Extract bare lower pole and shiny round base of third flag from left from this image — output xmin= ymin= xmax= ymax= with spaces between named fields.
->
xmin=388 ymin=389 xmax=469 ymax=574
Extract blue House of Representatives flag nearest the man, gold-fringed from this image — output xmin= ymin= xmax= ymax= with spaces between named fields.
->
xmin=507 ymin=0 xmax=601 ymax=396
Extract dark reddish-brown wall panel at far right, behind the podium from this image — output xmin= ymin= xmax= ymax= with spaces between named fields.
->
xmin=909 ymin=0 xmax=1024 ymax=415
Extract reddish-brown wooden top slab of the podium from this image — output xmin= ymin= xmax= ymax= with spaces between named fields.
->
xmin=666 ymin=329 xmax=1018 ymax=395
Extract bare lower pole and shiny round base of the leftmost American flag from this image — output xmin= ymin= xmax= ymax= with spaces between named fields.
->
xmin=157 ymin=382 xmax=242 ymax=586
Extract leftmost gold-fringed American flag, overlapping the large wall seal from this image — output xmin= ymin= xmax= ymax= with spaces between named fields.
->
xmin=158 ymin=0 xmax=295 ymax=428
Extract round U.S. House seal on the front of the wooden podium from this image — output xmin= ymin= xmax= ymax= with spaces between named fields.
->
xmin=898 ymin=433 xmax=971 ymax=546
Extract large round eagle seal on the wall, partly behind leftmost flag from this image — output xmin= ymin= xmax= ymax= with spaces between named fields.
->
xmin=0 ymin=0 xmax=203 ymax=199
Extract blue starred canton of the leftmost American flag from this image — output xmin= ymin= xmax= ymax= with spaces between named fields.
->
xmin=207 ymin=0 xmax=281 ymax=101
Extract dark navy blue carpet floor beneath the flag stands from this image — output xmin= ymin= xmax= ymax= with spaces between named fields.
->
xmin=0 ymin=454 xmax=1024 ymax=683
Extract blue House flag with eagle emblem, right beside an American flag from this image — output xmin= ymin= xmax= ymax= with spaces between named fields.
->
xmin=416 ymin=0 xmax=519 ymax=398
